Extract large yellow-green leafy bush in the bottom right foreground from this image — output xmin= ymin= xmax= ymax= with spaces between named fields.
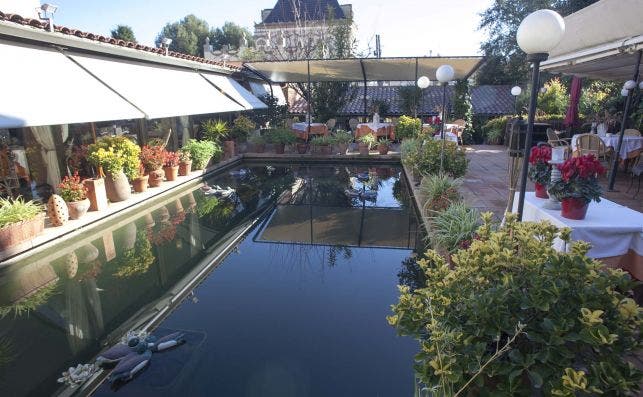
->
xmin=388 ymin=213 xmax=643 ymax=396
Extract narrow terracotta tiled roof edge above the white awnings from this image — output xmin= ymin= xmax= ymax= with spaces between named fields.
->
xmin=0 ymin=11 xmax=240 ymax=71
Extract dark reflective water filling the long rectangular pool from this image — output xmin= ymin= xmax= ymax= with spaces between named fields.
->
xmin=0 ymin=164 xmax=417 ymax=396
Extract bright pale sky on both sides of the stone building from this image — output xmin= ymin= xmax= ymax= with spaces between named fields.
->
xmin=45 ymin=0 xmax=491 ymax=56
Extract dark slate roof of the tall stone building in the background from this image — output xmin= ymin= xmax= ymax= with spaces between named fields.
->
xmin=263 ymin=0 xmax=346 ymax=23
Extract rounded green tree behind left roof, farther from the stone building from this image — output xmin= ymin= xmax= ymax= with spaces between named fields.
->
xmin=155 ymin=14 xmax=210 ymax=56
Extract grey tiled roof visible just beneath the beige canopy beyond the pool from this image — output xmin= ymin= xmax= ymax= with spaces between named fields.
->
xmin=290 ymin=85 xmax=514 ymax=116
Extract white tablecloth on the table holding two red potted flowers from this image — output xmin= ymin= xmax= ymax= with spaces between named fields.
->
xmin=513 ymin=192 xmax=643 ymax=258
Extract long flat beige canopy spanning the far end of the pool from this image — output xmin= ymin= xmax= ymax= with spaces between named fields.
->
xmin=245 ymin=56 xmax=482 ymax=83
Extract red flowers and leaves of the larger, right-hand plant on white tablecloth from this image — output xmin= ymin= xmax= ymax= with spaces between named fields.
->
xmin=549 ymin=154 xmax=605 ymax=203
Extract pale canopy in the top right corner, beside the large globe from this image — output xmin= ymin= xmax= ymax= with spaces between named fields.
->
xmin=541 ymin=0 xmax=643 ymax=81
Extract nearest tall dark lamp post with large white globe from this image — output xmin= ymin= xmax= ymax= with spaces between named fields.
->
xmin=516 ymin=10 xmax=565 ymax=221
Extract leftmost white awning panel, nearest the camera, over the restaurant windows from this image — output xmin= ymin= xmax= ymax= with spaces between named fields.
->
xmin=0 ymin=40 xmax=144 ymax=128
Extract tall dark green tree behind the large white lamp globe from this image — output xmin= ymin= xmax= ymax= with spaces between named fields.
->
xmin=477 ymin=0 xmax=598 ymax=84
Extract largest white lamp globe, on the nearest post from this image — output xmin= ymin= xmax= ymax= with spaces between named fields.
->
xmin=516 ymin=10 xmax=565 ymax=54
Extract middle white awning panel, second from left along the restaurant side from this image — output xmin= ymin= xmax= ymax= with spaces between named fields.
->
xmin=68 ymin=53 xmax=245 ymax=119
